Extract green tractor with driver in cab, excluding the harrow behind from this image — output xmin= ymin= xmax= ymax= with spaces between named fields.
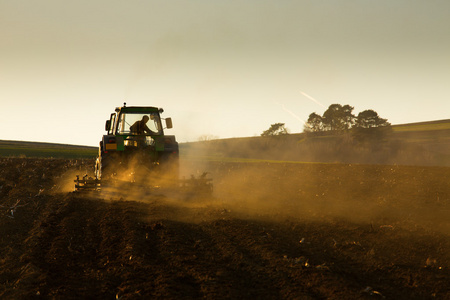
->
xmin=95 ymin=103 xmax=179 ymax=180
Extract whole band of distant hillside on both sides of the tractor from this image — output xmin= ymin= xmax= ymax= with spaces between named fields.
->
xmin=0 ymin=119 xmax=450 ymax=166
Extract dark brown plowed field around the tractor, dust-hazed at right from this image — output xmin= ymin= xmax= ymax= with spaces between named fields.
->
xmin=0 ymin=158 xmax=450 ymax=299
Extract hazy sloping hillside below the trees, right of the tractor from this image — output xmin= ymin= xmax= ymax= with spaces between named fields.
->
xmin=180 ymin=119 xmax=450 ymax=166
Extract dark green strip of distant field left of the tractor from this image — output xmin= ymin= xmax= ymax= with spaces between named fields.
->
xmin=0 ymin=140 xmax=98 ymax=158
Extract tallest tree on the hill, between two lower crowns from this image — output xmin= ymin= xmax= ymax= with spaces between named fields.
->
xmin=322 ymin=104 xmax=355 ymax=131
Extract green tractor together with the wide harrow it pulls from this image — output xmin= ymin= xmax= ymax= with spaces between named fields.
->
xmin=75 ymin=103 xmax=212 ymax=191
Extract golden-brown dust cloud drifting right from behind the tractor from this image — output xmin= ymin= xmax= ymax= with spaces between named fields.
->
xmin=63 ymin=141 xmax=450 ymax=237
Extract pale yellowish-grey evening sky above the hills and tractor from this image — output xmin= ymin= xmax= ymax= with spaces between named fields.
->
xmin=0 ymin=0 xmax=450 ymax=146
